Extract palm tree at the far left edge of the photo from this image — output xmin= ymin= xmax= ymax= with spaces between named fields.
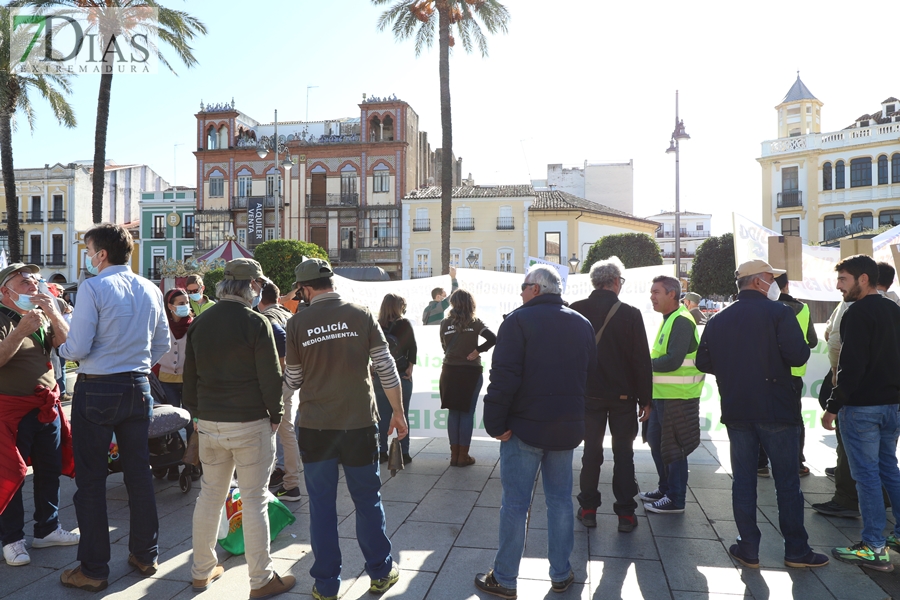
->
xmin=0 ymin=6 xmax=75 ymax=263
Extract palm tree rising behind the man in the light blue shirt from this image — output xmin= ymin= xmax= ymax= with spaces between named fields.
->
xmin=29 ymin=0 xmax=206 ymax=223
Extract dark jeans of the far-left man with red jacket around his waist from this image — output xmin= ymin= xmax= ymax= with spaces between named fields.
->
xmin=0 ymin=409 xmax=62 ymax=546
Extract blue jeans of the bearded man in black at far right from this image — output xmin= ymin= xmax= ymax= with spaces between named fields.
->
xmin=838 ymin=404 xmax=900 ymax=548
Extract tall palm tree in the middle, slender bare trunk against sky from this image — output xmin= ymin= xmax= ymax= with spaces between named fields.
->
xmin=372 ymin=0 xmax=509 ymax=273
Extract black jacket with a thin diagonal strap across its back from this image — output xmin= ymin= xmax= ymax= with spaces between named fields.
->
xmin=570 ymin=290 xmax=653 ymax=406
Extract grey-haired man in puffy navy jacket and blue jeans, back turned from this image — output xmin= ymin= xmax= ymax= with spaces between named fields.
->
xmin=475 ymin=265 xmax=597 ymax=598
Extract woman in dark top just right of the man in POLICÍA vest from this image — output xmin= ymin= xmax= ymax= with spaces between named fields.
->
xmin=372 ymin=294 xmax=416 ymax=464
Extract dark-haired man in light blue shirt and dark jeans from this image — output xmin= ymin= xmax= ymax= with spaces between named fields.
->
xmin=59 ymin=223 xmax=170 ymax=592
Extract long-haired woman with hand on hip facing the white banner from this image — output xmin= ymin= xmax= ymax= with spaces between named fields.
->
xmin=440 ymin=289 xmax=497 ymax=467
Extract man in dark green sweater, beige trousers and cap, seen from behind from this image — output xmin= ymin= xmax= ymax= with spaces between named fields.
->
xmin=183 ymin=258 xmax=295 ymax=598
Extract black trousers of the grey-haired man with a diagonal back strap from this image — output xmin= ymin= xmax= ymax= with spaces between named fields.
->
xmin=578 ymin=398 xmax=638 ymax=515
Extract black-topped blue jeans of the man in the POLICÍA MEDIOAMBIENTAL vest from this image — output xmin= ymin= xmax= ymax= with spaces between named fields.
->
xmin=299 ymin=426 xmax=393 ymax=596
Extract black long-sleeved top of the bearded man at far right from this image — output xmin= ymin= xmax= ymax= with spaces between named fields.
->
xmin=826 ymin=294 xmax=900 ymax=413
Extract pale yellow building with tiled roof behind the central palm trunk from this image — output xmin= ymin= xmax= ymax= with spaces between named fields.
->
xmin=401 ymin=185 xmax=659 ymax=279
